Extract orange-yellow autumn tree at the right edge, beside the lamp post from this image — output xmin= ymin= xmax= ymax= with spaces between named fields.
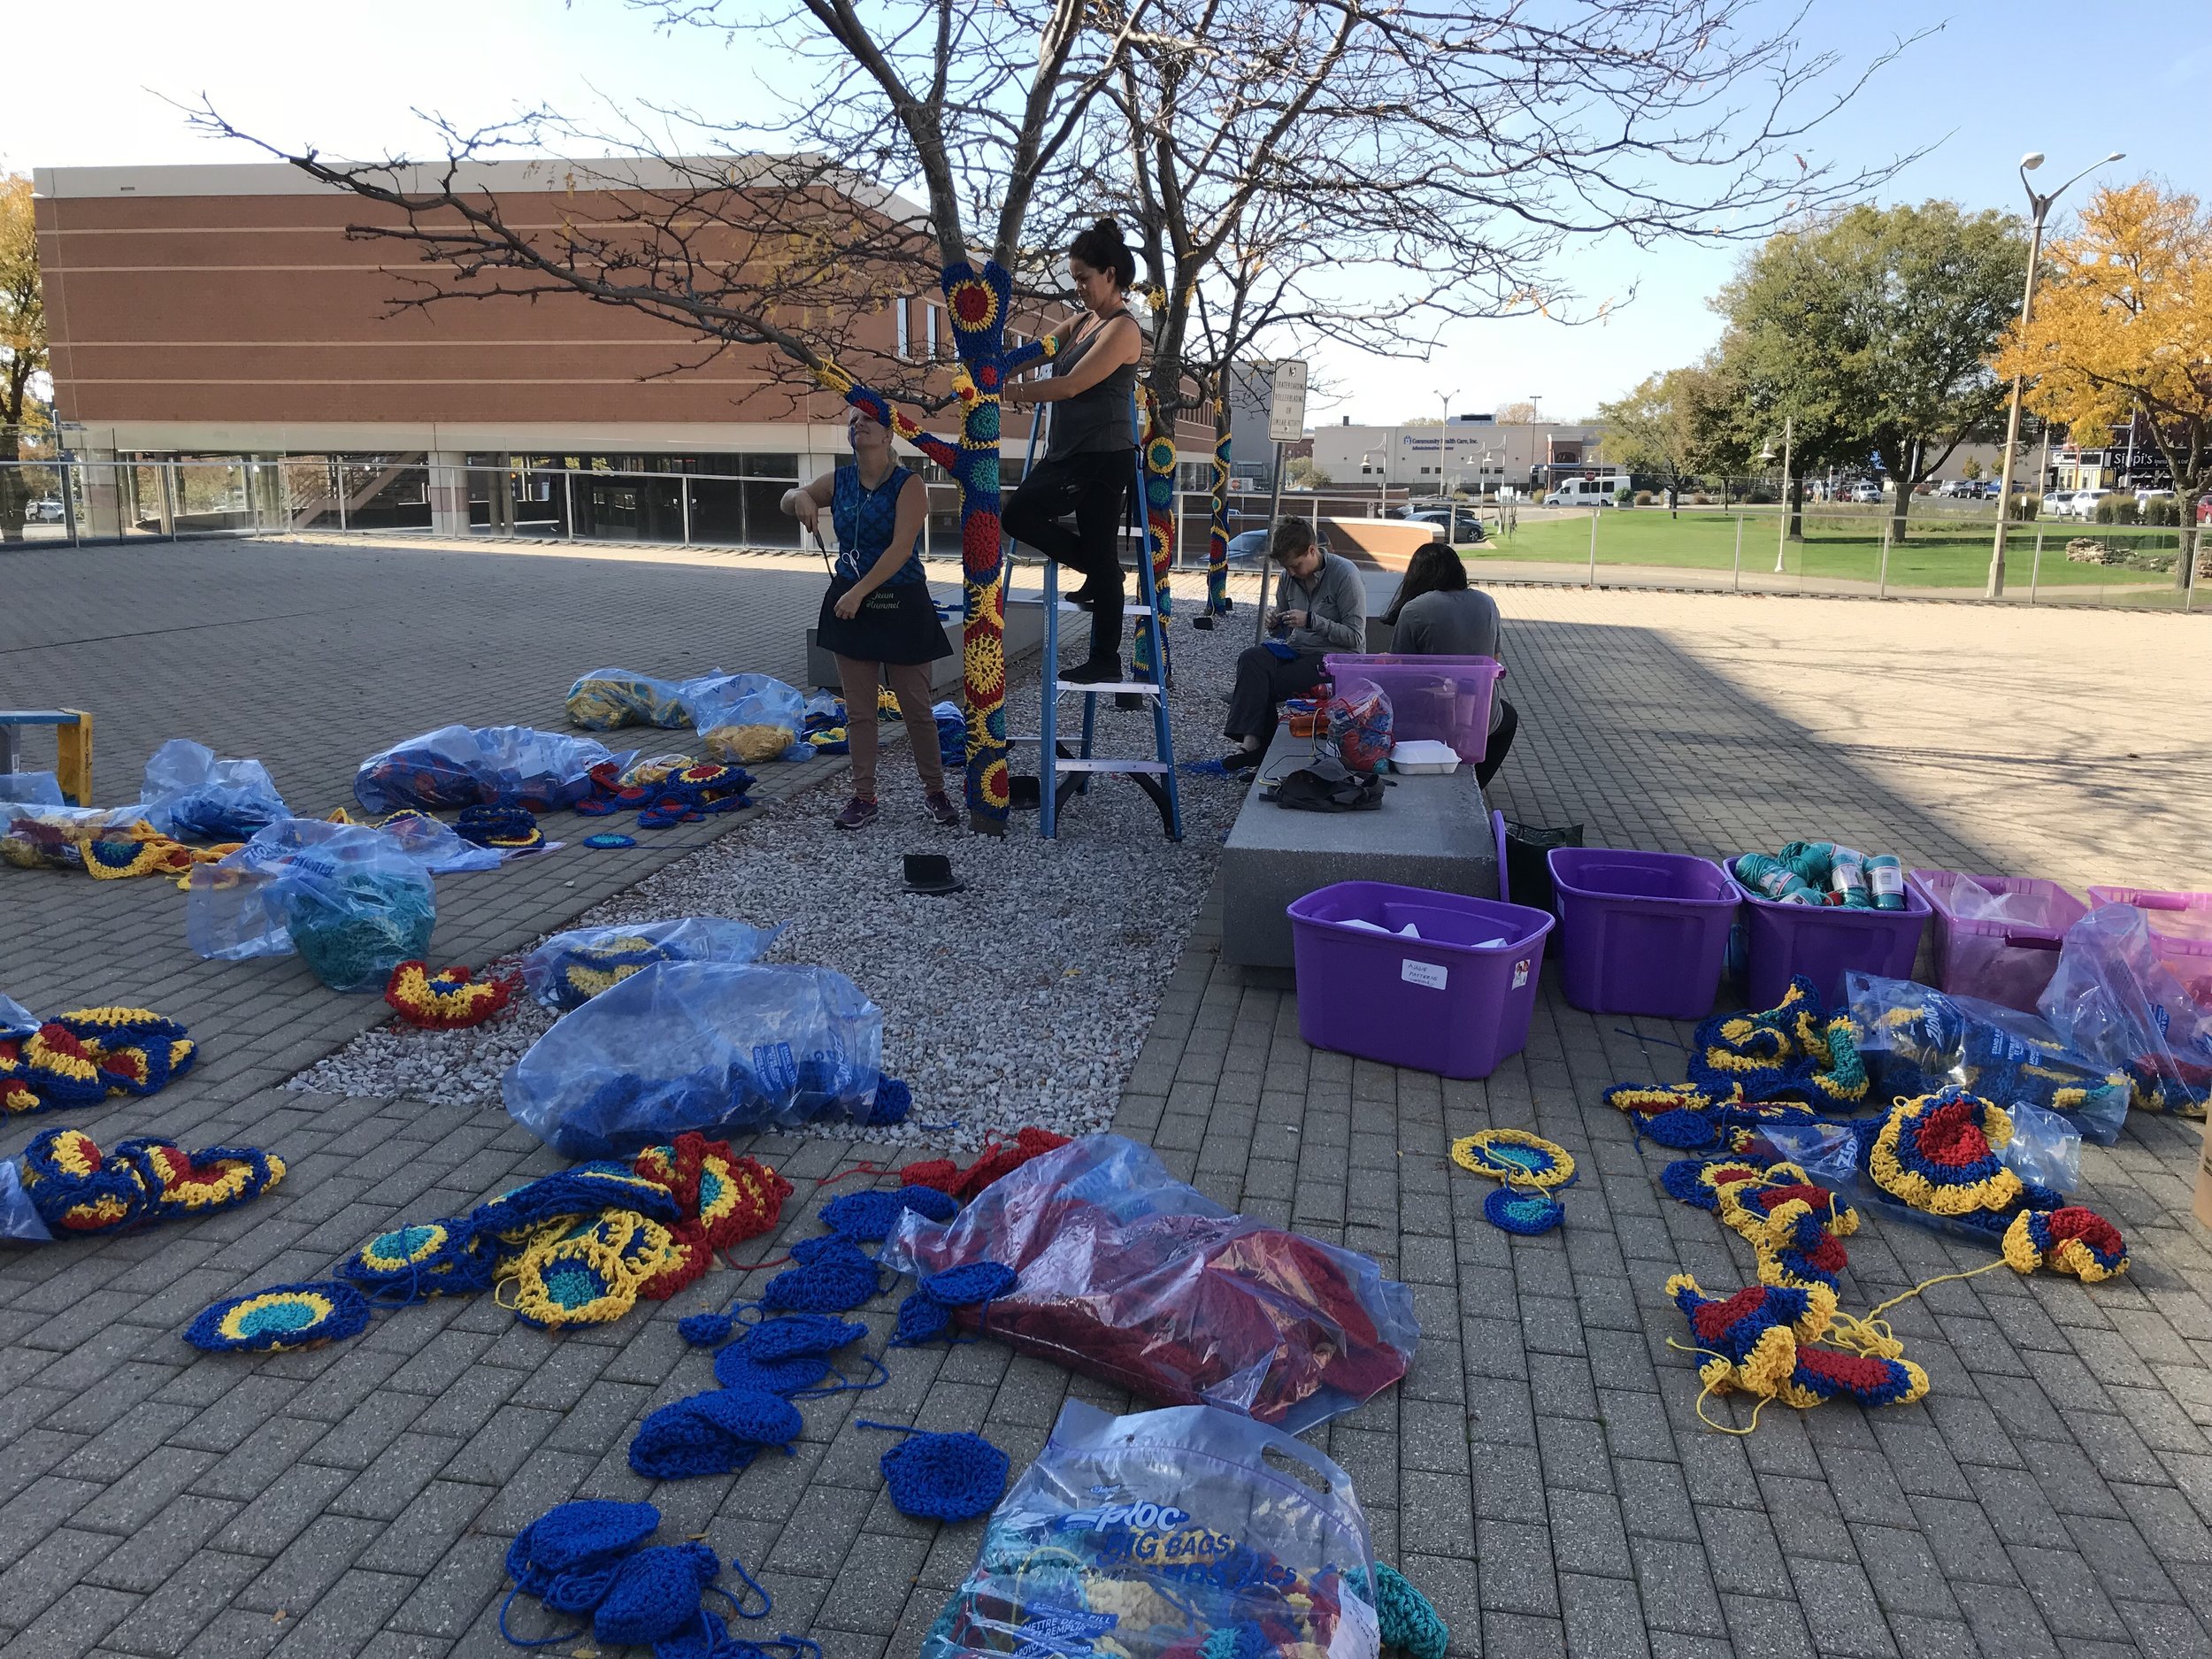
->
xmin=1995 ymin=180 xmax=2212 ymax=587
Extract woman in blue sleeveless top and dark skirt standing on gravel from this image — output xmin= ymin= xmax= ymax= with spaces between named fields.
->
xmin=783 ymin=410 xmax=960 ymax=830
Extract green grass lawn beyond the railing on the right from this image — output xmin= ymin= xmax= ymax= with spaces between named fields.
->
xmin=1463 ymin=507 xmax=2177 ymax=591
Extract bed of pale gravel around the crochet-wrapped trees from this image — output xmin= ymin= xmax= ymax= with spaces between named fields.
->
xmin=292 ymin=578 xmax=1252 ymax=1150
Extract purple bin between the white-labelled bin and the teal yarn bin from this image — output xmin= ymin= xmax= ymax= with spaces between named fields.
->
xmin=1547 ymin=848 xmax=1737 ymax=1020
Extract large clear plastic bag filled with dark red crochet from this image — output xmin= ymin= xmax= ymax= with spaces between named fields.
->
xmin=883 ymin=1135 xmax=1420 ymax=1432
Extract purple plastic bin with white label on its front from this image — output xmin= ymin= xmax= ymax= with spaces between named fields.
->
xmin=1290 ymin=880 xmax=1551 ymax=1078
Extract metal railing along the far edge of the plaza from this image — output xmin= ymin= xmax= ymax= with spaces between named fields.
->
xmin=0 ymin=456 xmax=2212 ymax=611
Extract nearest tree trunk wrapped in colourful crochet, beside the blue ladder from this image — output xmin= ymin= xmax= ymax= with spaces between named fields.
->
xmin=818 ymin=259 xmax=1057 ymax=836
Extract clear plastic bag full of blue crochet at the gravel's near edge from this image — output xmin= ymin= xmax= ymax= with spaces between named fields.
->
xmin=500 ymin=963 xmax=883 ymax=1159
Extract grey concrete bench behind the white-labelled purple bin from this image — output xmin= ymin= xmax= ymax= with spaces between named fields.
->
xmin=1221 ymin=726 xmax=1498 ymax=969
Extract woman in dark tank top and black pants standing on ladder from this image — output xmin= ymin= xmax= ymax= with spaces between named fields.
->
xmin=1002 ymin=219 xmax=1144 ymax=686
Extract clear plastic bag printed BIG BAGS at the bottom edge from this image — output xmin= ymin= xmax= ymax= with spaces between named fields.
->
xmin=920 ymin=1401 xmax=1383 ymax=1659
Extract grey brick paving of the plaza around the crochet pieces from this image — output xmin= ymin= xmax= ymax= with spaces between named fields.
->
xmin=0 ymin=544 xmax=2212 ymax=1659
